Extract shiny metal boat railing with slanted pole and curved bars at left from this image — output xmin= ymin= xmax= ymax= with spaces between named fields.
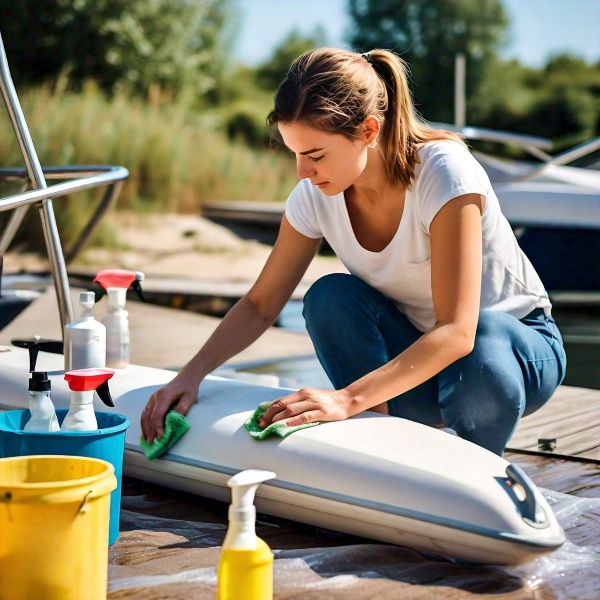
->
xmin=0 ymin=34 xmax=129 ymax=331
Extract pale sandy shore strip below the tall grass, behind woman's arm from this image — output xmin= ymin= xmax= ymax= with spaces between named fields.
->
xmin=4 ymin=213 xmax=345 ymax=283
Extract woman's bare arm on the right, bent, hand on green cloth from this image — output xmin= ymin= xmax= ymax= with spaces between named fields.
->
xmin=261 ymin=194 xmax=483 ymax=426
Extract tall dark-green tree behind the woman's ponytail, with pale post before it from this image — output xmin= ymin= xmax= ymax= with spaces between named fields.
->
xmin=349 ymin=0 xmax=508 ymax=122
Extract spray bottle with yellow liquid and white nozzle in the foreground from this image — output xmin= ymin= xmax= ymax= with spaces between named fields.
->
xmin=217 ymin=469 xmax=275 ymax=600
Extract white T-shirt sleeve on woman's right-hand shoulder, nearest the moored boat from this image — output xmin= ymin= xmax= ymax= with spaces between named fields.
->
xmin=415 ymin=141 xmax=491 ymax=233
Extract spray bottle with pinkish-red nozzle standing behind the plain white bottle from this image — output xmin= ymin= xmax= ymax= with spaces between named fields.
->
xmin=94 ymin=269 xmax=144 ymax=369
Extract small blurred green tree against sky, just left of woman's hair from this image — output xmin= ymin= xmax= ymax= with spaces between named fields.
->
xmin=256 ymin=27 xmax=326 ymax=91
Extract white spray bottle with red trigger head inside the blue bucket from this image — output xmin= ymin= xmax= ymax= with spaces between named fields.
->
xmin=62 ymin=369 xmax=114 ymax=431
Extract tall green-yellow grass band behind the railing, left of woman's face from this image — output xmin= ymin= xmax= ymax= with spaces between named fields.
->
xmin=0 ymin=84 xmax=297 ymax=251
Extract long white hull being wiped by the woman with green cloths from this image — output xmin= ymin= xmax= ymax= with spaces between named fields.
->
xmin=0 ymin=347 xmax=564 ymax=564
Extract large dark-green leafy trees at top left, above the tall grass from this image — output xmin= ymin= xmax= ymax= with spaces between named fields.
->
xmin=0 ymin=0 xmax=230 ymax=99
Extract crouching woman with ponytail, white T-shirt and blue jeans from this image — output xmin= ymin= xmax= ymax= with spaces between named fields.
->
xmin=142 ymin=48 xmax=566 ymax=455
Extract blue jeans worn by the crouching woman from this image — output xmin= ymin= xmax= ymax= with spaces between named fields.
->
xmin=303 ymin=273 xmax=566 ymax=455
